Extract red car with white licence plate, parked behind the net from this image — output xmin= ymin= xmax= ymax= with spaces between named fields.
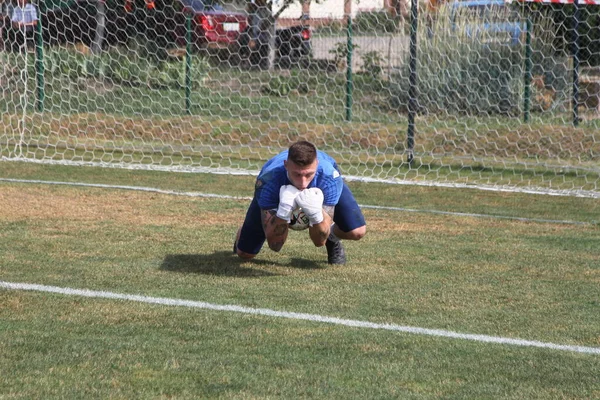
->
xmin=176 ymin=0 xmax=248 ymax=54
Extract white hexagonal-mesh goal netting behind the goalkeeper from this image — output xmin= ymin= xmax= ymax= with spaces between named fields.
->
xmin=0 ymin=0 xmax=600 ymax=197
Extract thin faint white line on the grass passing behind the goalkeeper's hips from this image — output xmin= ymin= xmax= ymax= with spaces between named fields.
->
xmin=0 ymin=178 xmax=596 ymax=225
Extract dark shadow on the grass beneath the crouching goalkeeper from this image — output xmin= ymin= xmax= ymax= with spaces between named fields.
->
xmin=160 ymin=251 xmax=323 ymax=278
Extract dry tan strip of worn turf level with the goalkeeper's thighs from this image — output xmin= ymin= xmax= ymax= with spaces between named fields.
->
xmin=0 ymin=185 xmax=592 ymax=236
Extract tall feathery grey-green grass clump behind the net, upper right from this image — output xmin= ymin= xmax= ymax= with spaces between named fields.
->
xmin=390 ymin=5 xmax=567 ymax=115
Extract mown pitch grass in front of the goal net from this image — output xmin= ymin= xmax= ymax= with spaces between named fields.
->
xmin=0 ymin=162 xmax=600 ymax=399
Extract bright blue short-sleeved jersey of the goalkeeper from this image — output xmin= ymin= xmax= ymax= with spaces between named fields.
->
xmin=254 ymin=150 xmax=344 ymax=210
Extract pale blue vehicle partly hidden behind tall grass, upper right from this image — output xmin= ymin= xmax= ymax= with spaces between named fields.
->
xmin=450 ymin=0 xmax=526 ymax=46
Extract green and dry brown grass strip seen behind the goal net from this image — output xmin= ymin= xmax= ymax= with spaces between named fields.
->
xmin=0 ymin=49 xmax=600 ymax=197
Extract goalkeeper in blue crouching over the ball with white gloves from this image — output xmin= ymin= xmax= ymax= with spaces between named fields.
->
xmin=233 ymin=141 xmax=366 ymax=264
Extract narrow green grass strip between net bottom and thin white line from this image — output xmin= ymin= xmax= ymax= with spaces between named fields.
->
xmin=0 ymin=162 xmax=600 ymax=224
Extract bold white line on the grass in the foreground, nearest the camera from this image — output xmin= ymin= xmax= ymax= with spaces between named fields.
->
xmin=0 ymin=281 xmax=600 ymax=355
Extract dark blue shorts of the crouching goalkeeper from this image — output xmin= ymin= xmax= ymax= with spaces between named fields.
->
xmin=238 ymin=183 xmax=366 ymax=254
